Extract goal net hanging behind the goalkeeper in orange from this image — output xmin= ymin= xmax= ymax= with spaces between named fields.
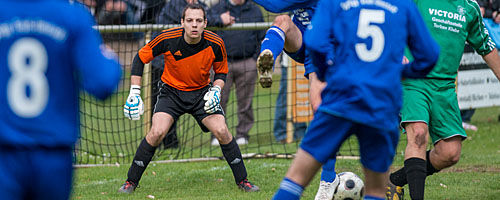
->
xmin=74 ymin=0 xmax=358 ymax=166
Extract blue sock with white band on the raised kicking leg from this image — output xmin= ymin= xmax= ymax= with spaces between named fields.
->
xmin=260 ymin=26 xmax=285 ymax=60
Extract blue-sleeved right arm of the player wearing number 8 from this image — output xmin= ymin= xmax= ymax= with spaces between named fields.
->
xmin=72 ymin=5 xmax=122 ymax=99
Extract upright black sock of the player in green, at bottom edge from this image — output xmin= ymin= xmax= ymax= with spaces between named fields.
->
xmin=405 ymin=158 xmax=427 ymax=200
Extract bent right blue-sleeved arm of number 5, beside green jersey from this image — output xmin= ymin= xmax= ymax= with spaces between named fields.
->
xmin=403 ymin=4 xmax=439 ymax=78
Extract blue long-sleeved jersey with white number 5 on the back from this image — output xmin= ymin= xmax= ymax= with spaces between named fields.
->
xmin=305 ymin=0 xmax=439 ymax=129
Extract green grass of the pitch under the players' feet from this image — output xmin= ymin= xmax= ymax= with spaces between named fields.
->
xmin=72 ymin=107 xmax=500 ymax=200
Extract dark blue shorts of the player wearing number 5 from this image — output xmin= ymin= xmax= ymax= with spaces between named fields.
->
xmin=300 ymin=111 xmax=399 ymax=173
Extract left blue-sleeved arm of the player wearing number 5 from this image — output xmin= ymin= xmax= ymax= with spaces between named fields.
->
xmin=304 ymin=1 xmax=335 ymax=81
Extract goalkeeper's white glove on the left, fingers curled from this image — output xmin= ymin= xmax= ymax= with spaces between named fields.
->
xmin=123 ymin=85 xmax=144 ymax=120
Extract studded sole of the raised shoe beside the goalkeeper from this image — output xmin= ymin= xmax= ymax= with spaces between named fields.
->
xmin=257 ymin=49 xmax=274 ymax=88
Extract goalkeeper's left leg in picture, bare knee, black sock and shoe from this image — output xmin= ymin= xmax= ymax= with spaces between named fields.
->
xmin=118 ymin=111 xmax=174 ymax=193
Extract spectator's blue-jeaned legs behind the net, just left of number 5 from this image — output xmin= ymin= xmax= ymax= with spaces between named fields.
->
xmin=274 ymin=54 xmax=307 ymax=143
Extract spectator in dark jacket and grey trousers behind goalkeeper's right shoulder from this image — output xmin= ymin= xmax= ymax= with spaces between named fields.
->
xmin=209 ymin=0 xmax=265 ymax=146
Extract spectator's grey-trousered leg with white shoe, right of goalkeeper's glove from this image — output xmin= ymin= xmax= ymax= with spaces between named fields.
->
xmin=233 ymin=58 xmax=257 ymax=145
